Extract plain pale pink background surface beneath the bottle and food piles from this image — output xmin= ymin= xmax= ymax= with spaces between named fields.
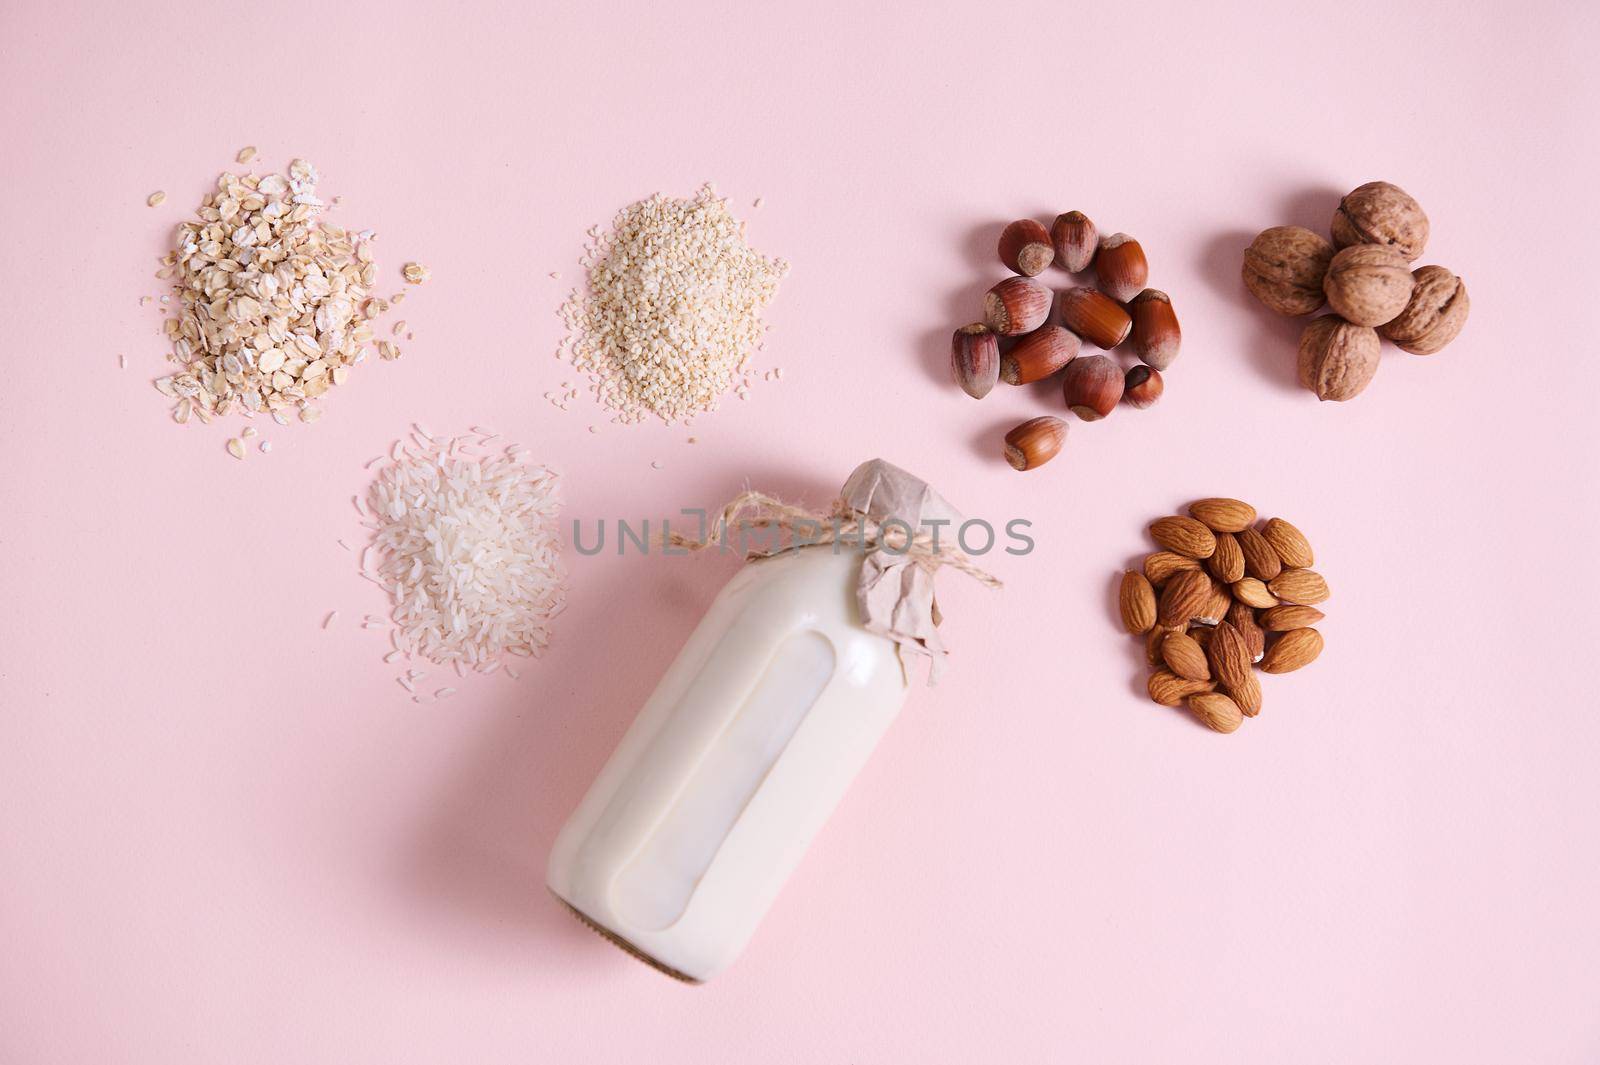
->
xmin=0 ymin=0 xmax=1600 ymax=1065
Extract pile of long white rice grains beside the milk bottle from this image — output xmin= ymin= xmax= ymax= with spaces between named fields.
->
xmin=357 ymin=427 xmax=566 ymax=672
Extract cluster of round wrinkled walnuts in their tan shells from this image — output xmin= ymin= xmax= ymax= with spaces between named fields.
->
xmin=1243 ymin=181 xmax=1470 ymax=400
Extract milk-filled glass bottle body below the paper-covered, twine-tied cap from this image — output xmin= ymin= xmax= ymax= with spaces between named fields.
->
xmin=547 ymin=545 xmax=907 ymax=980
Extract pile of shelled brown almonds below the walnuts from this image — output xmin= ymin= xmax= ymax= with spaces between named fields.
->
xmin=1118 ymin=499 xmax=1328 ymax=732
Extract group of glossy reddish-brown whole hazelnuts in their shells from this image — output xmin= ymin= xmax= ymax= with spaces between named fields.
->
xmin=950 ymin=211 xmax=1182 ymax=470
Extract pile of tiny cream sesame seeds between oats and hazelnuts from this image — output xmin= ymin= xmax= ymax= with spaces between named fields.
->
xmin=560 ymin=184 xmax=789 ymax=424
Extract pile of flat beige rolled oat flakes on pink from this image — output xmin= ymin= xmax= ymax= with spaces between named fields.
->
xmin=155 ymin=152 xmax=402 ymax=425
